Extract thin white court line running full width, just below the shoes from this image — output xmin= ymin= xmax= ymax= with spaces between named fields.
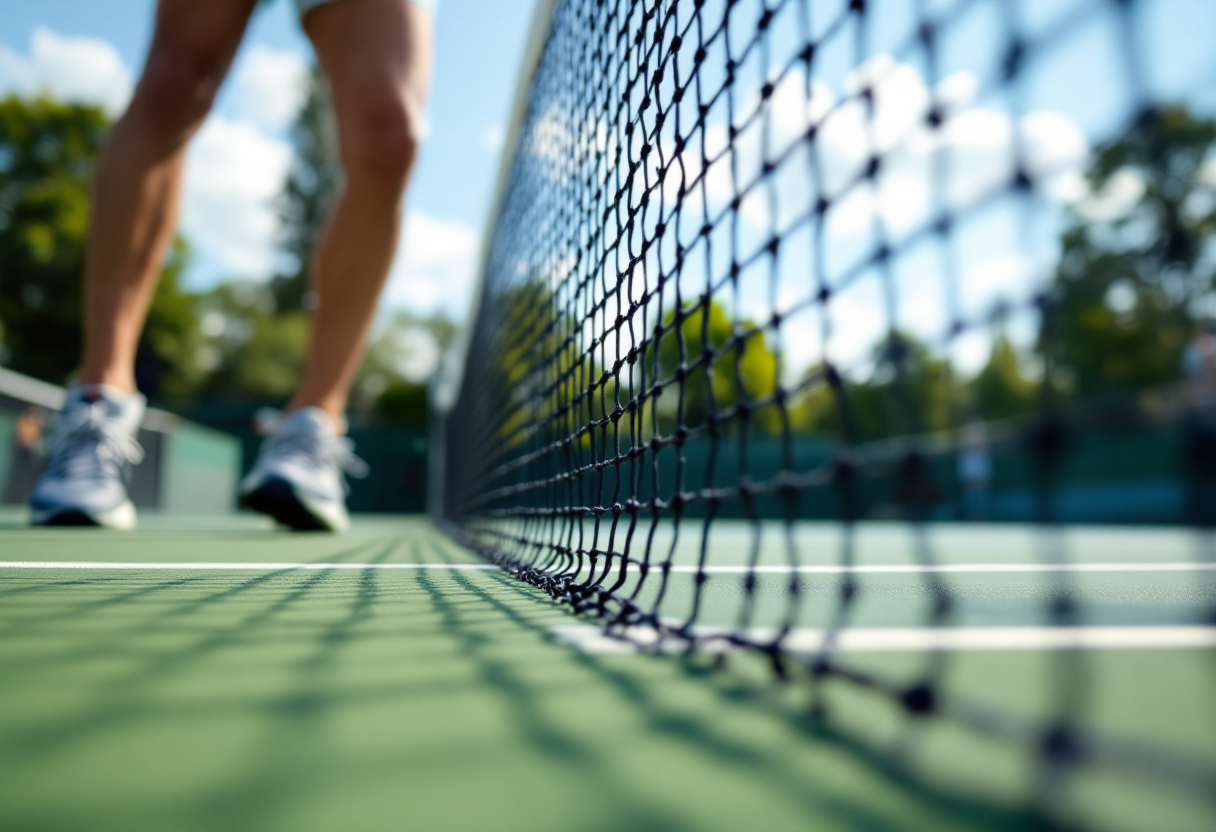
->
xmin=0 ymin=561 xmax=1216 ymax=575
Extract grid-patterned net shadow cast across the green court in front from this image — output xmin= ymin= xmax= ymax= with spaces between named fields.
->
xmin=0 ymin=532 xmax=1065 ymax=830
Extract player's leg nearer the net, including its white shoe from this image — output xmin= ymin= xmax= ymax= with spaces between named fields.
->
xmin=242 ymin=0 xmax=430 ymax=529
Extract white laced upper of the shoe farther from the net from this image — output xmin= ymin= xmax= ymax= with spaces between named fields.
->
xmin=47 ymin=400 xmax=143 ymax=479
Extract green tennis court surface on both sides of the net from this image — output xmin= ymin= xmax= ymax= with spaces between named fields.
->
xmin=0 ymin=517 xmax=1216 ymax=832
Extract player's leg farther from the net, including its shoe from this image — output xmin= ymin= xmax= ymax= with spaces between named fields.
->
xmin=29 ymin=0 xmax=255 ymax=528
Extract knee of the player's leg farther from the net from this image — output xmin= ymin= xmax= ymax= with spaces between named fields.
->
xmin=131 ymin=43 xmax=224 ymax=133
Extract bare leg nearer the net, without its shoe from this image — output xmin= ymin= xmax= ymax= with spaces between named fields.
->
xmin=292 ymin=0 xmax=430 ymax=426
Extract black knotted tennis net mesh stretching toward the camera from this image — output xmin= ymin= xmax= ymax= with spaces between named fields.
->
xmin=439 ymin=0 xmax=1216 ymax=817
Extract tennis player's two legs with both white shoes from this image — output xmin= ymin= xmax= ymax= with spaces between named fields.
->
xmin=29 ymin=0 xmax=433 ymax=530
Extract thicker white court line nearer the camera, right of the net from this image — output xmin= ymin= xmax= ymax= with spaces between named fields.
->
xmin=552 ymin=624 xmax=1216 ymax=653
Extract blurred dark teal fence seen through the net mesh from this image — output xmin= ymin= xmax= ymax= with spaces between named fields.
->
xmin=661 ymin=421 xmax=1214 ymax=523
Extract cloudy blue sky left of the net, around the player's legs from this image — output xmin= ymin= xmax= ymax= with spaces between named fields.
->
xmin=0 ymin=0 xmax=534 ymax=316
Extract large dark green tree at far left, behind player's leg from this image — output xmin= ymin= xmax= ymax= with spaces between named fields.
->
xmin=0 ymin=97 xmax=203 ymax=398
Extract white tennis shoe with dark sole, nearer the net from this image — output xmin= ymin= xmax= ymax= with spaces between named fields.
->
xmin=241 ymin=407 xmax=367 ymax=532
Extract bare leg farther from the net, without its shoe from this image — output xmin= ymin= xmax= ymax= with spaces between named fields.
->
xmin=79 ymin=0 xmax=257 ymax=392
